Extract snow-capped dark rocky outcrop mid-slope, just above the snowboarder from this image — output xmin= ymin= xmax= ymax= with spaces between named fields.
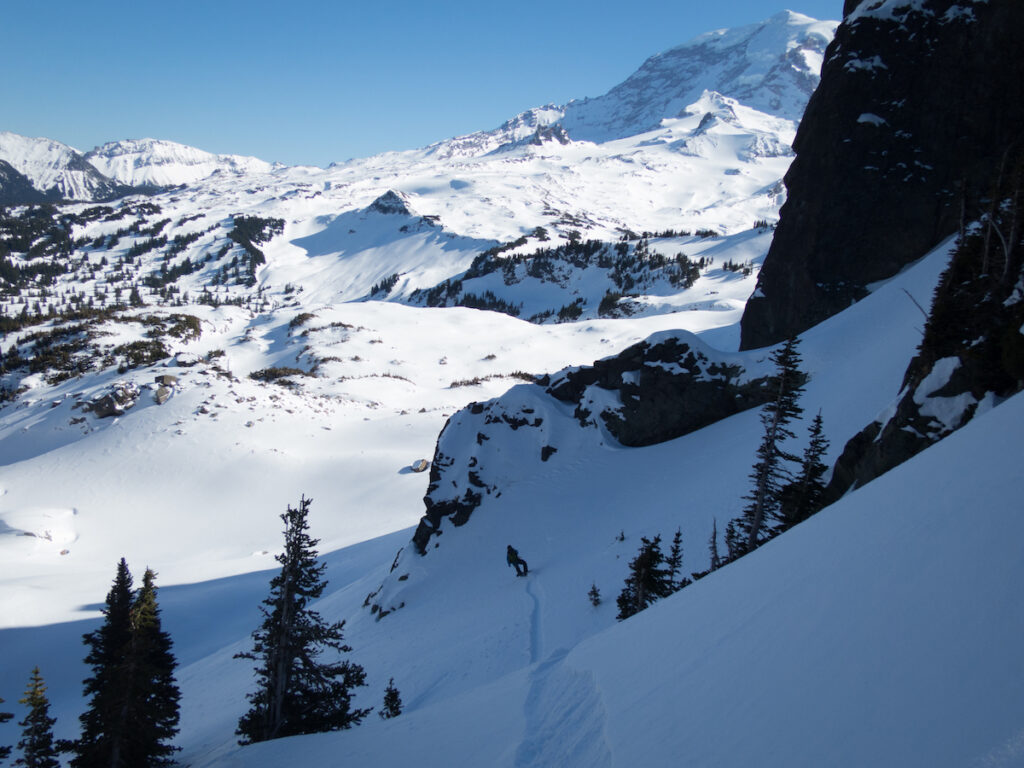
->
xmin=413 ymin=332 xmax=774 ymax=554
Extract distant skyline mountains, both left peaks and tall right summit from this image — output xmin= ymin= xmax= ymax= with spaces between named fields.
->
xmin=0 ymin=11 xmax=836 ymax=205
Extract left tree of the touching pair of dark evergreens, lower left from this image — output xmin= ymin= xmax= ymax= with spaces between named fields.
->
xmin=70 ymin=557 xmax=132 ymax=768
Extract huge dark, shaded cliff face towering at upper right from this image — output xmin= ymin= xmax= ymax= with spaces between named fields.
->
xmin=741 ymin=0 xmax=1024 ymax=349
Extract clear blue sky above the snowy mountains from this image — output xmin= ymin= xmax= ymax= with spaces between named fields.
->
xmin=0 ymin=0 xmax=842 ymax=165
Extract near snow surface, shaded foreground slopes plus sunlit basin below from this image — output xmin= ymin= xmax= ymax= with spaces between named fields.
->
xmin=0 ymin=230 xmax=1024 ymax=767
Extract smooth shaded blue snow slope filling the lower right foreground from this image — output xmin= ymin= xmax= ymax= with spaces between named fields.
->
xmin=211 ymin=396 xmax=1024 ymax=768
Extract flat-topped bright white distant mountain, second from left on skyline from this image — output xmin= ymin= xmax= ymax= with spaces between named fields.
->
xmin=85 ymin=138 xmax=273 ymax=186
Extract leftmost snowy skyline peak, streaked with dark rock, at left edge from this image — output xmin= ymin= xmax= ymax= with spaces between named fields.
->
xmin=0 ymin=131 xmax=129 ymax=200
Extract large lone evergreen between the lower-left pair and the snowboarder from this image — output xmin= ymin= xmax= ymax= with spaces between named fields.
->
xmin=236 ymin=497 xmax=370 ymax=744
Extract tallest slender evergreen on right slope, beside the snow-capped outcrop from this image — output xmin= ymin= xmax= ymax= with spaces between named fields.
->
xmin=726 ymin=338 xmax=807 ymax=559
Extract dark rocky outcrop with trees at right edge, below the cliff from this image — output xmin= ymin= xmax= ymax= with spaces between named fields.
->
xmin=826 ymin=141 xmax=1024 ymax=501
